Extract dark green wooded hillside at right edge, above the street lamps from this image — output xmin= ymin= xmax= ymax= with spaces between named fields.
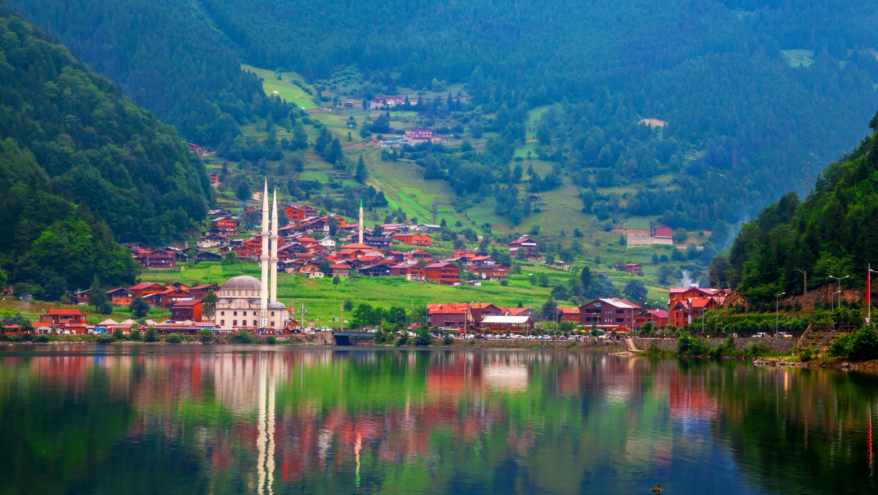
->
xmin=714 ymin=110 xmax=878 ymax=302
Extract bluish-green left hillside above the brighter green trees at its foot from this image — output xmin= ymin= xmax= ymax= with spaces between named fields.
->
xmin=0 ymin=4 xmax=212 ymax=241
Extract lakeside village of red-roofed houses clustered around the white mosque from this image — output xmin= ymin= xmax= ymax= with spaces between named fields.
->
xmin=3 ymin=186 xmax=729 ymax=336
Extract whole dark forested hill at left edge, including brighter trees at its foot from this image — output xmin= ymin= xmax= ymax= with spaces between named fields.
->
xmin=0 ymin=6 xmax=212 ymax=297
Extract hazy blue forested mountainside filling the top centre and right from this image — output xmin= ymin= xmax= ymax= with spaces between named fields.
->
xmin=191 ymin=0 xmax=878 ymax=228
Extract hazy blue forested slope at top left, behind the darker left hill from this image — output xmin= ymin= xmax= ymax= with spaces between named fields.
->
xmin=3 ymin=0 xmax=290 ymax=147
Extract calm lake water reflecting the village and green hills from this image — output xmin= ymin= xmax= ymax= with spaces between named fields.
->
xmin=0 ymin=346 xmax=878 ymax=495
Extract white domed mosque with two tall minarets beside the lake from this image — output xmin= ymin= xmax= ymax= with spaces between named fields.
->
xmin=214 ymin=181 xmax=290 ymax=330
